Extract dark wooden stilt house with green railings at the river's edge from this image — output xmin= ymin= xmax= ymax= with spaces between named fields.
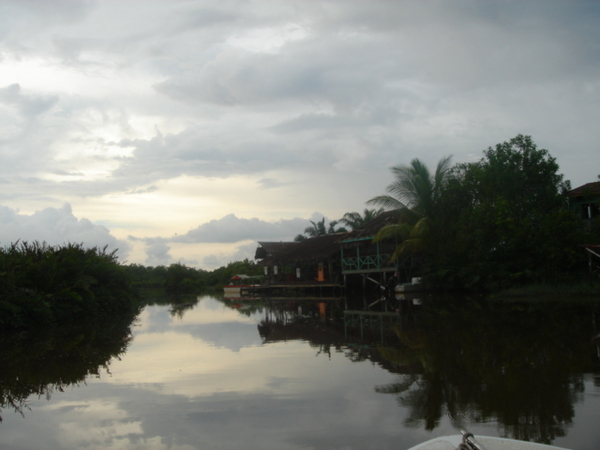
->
xmin=255 ymin=211 xmax=415 ymax=295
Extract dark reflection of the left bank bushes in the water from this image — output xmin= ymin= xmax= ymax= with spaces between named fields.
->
xmin=0 ymin=316 xmax=135 ymax=420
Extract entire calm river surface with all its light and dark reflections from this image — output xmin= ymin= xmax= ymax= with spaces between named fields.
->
xmin=0 ymin=296 xmax=600 ymax=450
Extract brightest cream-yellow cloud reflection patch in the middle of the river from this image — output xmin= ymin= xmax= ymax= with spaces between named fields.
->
xmin=106 ymin=330 xmax=345 ymax=397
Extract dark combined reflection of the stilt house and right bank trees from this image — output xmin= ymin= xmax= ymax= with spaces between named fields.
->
xmin=218 ymin=298 xmax=599 ymax=443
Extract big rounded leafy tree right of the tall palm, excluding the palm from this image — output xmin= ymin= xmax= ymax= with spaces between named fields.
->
xmin=430 ymin=135 xmax=578 ymax=289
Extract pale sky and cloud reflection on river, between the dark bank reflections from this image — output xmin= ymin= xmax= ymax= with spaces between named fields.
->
xmin=7 ymin=300 xmax=600 ymax=450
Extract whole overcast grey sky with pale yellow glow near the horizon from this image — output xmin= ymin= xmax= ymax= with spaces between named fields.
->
xmin=0 ymin=0 xmax=600 ymax=270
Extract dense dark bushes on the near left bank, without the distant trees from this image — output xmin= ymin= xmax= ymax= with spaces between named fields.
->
xmin=0 ymin=242 xmax=137 ymax=329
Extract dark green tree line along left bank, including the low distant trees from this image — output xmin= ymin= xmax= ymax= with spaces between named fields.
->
xmin=0 ymin=242 xmax=263 ymax=330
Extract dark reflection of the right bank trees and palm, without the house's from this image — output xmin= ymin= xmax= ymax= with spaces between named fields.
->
xmin=376 ymin=303 xmax=597 ymax=443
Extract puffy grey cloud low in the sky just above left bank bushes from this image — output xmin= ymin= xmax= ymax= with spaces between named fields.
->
xmin=0 ymin=204 xmax=129 ymax=260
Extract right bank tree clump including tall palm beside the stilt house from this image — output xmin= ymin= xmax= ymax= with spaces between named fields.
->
xmin=368 ymin=135 xmax=600 ymax=290
